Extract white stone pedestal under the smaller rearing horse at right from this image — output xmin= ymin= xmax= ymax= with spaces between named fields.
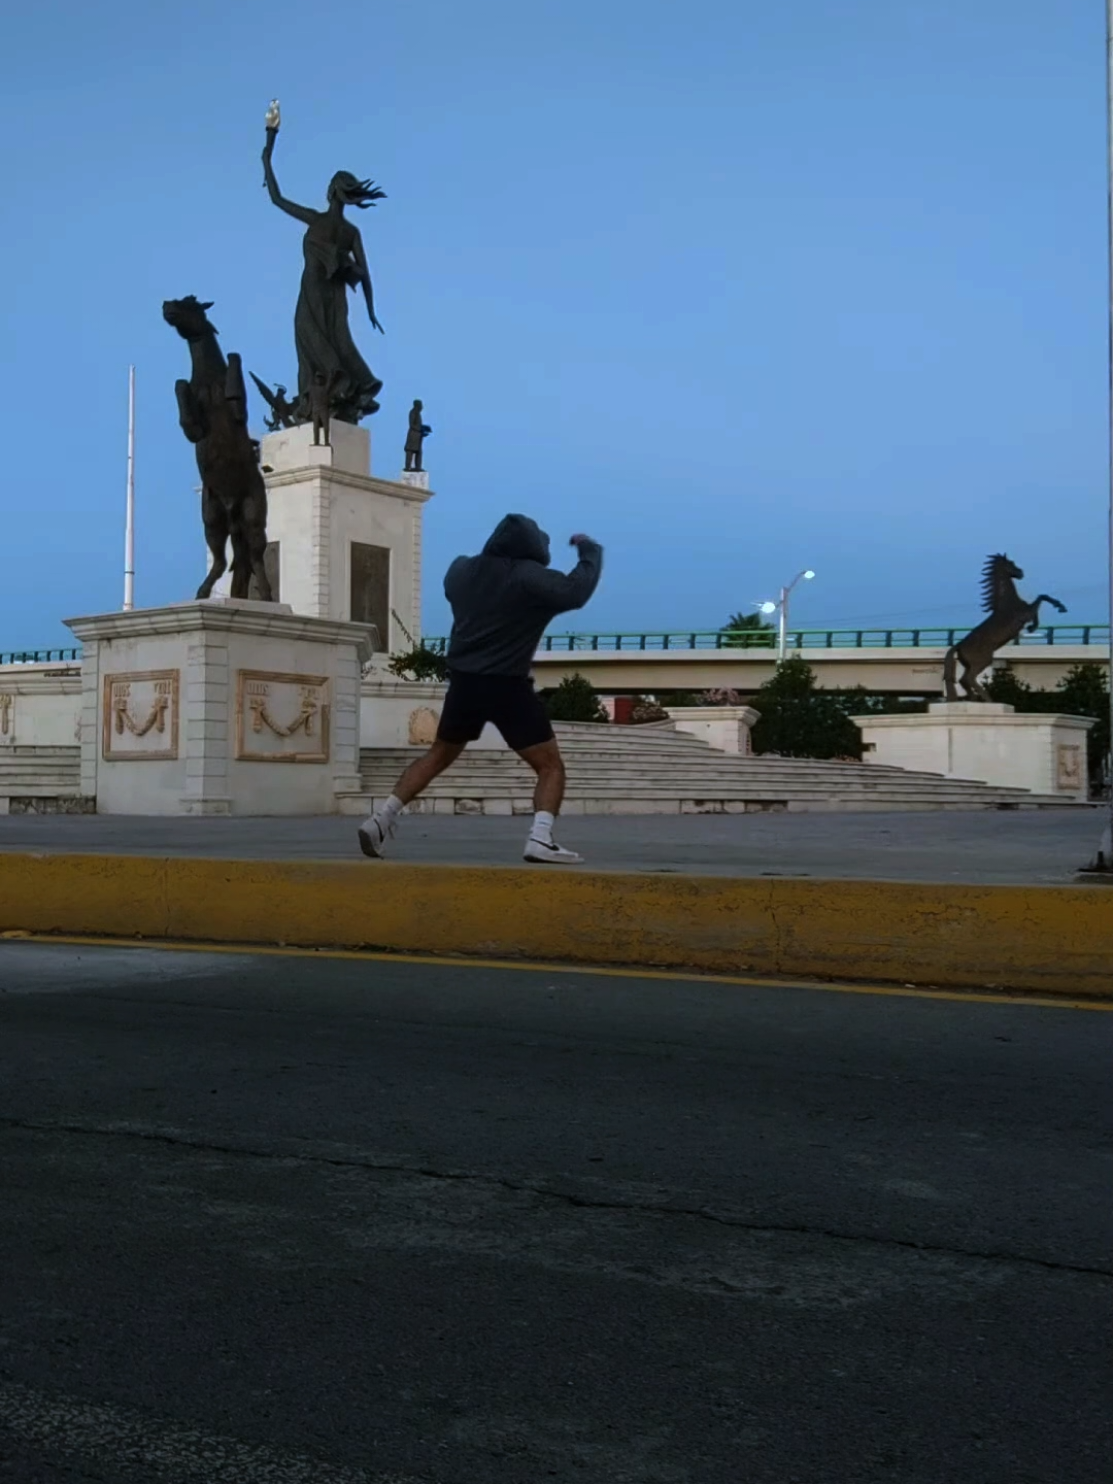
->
xmin=853 ymin=700 xmax=1094 ymax=803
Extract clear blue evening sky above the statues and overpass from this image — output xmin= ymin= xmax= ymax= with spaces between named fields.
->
xmin=0 ymin=0 xmax=1107 ymax=649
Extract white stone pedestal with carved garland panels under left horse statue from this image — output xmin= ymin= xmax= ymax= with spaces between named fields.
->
xmin=65 ymin=598 xmax=370 ymax=815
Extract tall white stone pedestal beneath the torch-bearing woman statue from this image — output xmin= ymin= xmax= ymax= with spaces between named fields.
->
xmin=215 ymin=423 xmax=433 ymax=653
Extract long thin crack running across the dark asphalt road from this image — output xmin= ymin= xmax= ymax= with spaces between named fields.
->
xmin=0 ymin=1117 xmax=1113 ymax=1278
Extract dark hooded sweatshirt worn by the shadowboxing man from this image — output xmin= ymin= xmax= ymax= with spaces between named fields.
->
xmin=444 ymin=515 xmax=603 ymax=675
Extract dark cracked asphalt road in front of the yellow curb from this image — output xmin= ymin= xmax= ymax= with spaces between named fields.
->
xmin=0 ymin=942 xmax=1113 ymax=1484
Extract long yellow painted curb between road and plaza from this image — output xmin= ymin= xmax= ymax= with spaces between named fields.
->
xmin=0 ymin=855 xmax=1113 ymax=997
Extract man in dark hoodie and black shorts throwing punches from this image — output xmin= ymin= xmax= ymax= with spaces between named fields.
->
xmin=359 ymin=515 xmax=603 ymax=865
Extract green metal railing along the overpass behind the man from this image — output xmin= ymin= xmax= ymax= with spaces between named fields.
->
xmin=424 ymin=623 xmax=1109 ymax=654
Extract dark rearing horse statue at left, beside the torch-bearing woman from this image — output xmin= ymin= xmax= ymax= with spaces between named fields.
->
xmin=162 ymin=294 xmax=273 ymax=603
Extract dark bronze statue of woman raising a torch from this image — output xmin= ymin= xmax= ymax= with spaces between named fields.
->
xmin=263 ymin=104 xmax=386 ymax=423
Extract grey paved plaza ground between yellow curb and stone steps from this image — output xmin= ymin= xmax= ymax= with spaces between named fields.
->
xmin=0 ymin=809 xmax=1104 ymax=884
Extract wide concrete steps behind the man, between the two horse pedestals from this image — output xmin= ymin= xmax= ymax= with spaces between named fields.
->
xmin=354 ymin=723 xmax=1071 ymax=815
